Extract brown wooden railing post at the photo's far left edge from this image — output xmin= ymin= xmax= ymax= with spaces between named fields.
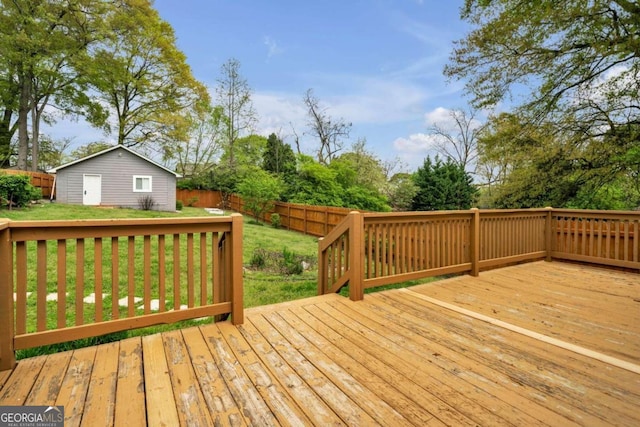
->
xmin=0 ymin=219 xmax=16 ymax=371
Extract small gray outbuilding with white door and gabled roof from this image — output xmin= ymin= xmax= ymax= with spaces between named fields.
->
xmin=47 ymin=145 xmax=180 ymax=211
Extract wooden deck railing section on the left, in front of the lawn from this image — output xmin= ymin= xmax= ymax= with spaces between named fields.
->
xmin=0 ymin=214 xmax=243 ymax=370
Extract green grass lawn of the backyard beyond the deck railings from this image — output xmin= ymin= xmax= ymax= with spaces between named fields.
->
xmin=0 ymin=202 xmax=436 ymax=358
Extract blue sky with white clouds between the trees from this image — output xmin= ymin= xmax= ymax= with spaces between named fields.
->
xmin=50 ymin=0 xmax=467 ymax=170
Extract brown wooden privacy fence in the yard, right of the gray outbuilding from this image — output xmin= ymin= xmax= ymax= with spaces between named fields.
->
xmin=176 ymin=189 xmax=352 ymax=237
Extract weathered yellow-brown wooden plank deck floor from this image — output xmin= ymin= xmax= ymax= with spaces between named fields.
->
xmin=0 ymin=262 xmax=640 ymax=426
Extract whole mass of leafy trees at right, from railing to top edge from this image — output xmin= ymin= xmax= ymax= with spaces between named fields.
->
xmin=445 ymin=0 xmax=640 ymax=208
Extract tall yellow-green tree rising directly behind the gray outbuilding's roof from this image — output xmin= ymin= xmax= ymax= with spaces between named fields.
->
xmin=83 ymin=0 xmax=208 ymax=151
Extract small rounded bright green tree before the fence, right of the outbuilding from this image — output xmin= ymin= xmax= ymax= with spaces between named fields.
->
xmin=238 ymin=169 xmax=283 ymax=224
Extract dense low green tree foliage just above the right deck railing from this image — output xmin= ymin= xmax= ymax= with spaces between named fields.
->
xmin=478 ymin=113 xmax=640 ymax=209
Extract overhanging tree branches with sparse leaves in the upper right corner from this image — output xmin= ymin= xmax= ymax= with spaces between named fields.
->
xmin=445 ymin=0 xmax=640 ymax=116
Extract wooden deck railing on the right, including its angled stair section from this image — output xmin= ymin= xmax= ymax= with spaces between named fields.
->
xmin=318 ymin=208 xmax=640 ymax=300
